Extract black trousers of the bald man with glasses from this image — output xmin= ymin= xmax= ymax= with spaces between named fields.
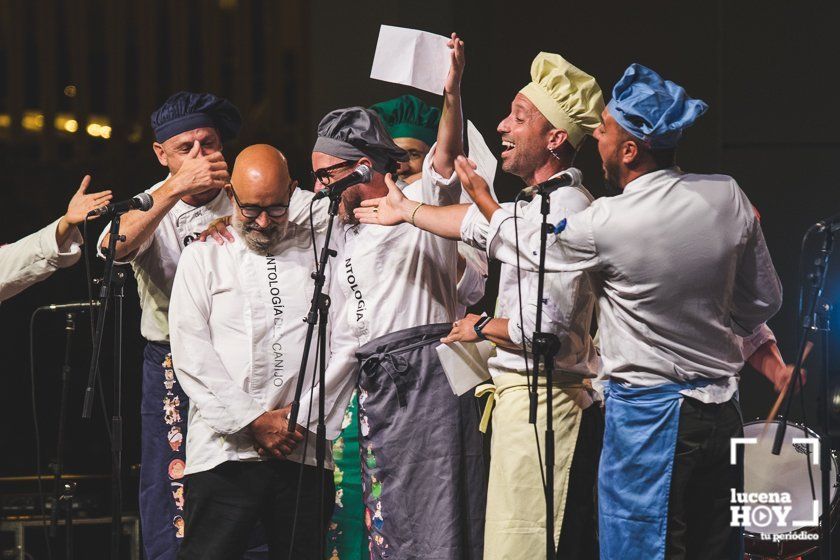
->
xmin=178 ymin=460 xmax=335 ymax=560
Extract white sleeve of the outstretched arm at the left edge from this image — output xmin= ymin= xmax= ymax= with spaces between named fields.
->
xmin=0 ymin=218 xmax=83 ymax=302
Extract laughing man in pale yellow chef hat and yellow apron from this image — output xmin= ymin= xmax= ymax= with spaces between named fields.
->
xmin=356 ymin=52 xmax=604 ymax=560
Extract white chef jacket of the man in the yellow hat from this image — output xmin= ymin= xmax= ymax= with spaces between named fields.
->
xmin=461 ymin=168 xmax=599 ymax=408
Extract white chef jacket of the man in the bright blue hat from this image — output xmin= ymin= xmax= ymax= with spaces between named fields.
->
xmin=488 ymin=168 xmax=782 ymax=403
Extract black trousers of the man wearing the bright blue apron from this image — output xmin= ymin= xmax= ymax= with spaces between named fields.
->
xmin=665 ymin=398 xmax=744 ymax=560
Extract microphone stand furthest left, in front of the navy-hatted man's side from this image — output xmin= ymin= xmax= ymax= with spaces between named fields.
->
xmin=82 ymin=210 xmax=127 ymax=560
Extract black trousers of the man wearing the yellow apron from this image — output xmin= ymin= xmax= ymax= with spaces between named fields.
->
xmin=557 ymin=402 xmax=604 ymax=560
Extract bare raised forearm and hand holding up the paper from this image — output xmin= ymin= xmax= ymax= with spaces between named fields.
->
xmin=432 ymin=33 xmax=465 ymax=177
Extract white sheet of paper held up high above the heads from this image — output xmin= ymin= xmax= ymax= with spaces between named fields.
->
xmin=370 ymin=25 xmax=450 ymax=95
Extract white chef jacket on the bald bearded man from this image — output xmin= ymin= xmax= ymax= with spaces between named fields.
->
xmin=169 ymin=221 xmax=355 ymax=474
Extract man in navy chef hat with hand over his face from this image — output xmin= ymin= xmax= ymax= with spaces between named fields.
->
xmin=99 ymin=91 xmax=278 ymax=560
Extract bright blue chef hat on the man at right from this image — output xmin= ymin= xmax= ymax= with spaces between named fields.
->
xmin=607 ymin=63 xmax=709 ymax=149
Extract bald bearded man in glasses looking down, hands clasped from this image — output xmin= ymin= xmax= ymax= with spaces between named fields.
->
xmin=170 ymin=145 xmax=355 ymax=560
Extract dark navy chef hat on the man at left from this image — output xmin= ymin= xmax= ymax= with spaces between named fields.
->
xmin=152 ymin=91 xmax=242 ymax=142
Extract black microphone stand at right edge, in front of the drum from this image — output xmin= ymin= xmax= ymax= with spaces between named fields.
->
xmin=772 ymin=223 xmax=834 ymax=560
